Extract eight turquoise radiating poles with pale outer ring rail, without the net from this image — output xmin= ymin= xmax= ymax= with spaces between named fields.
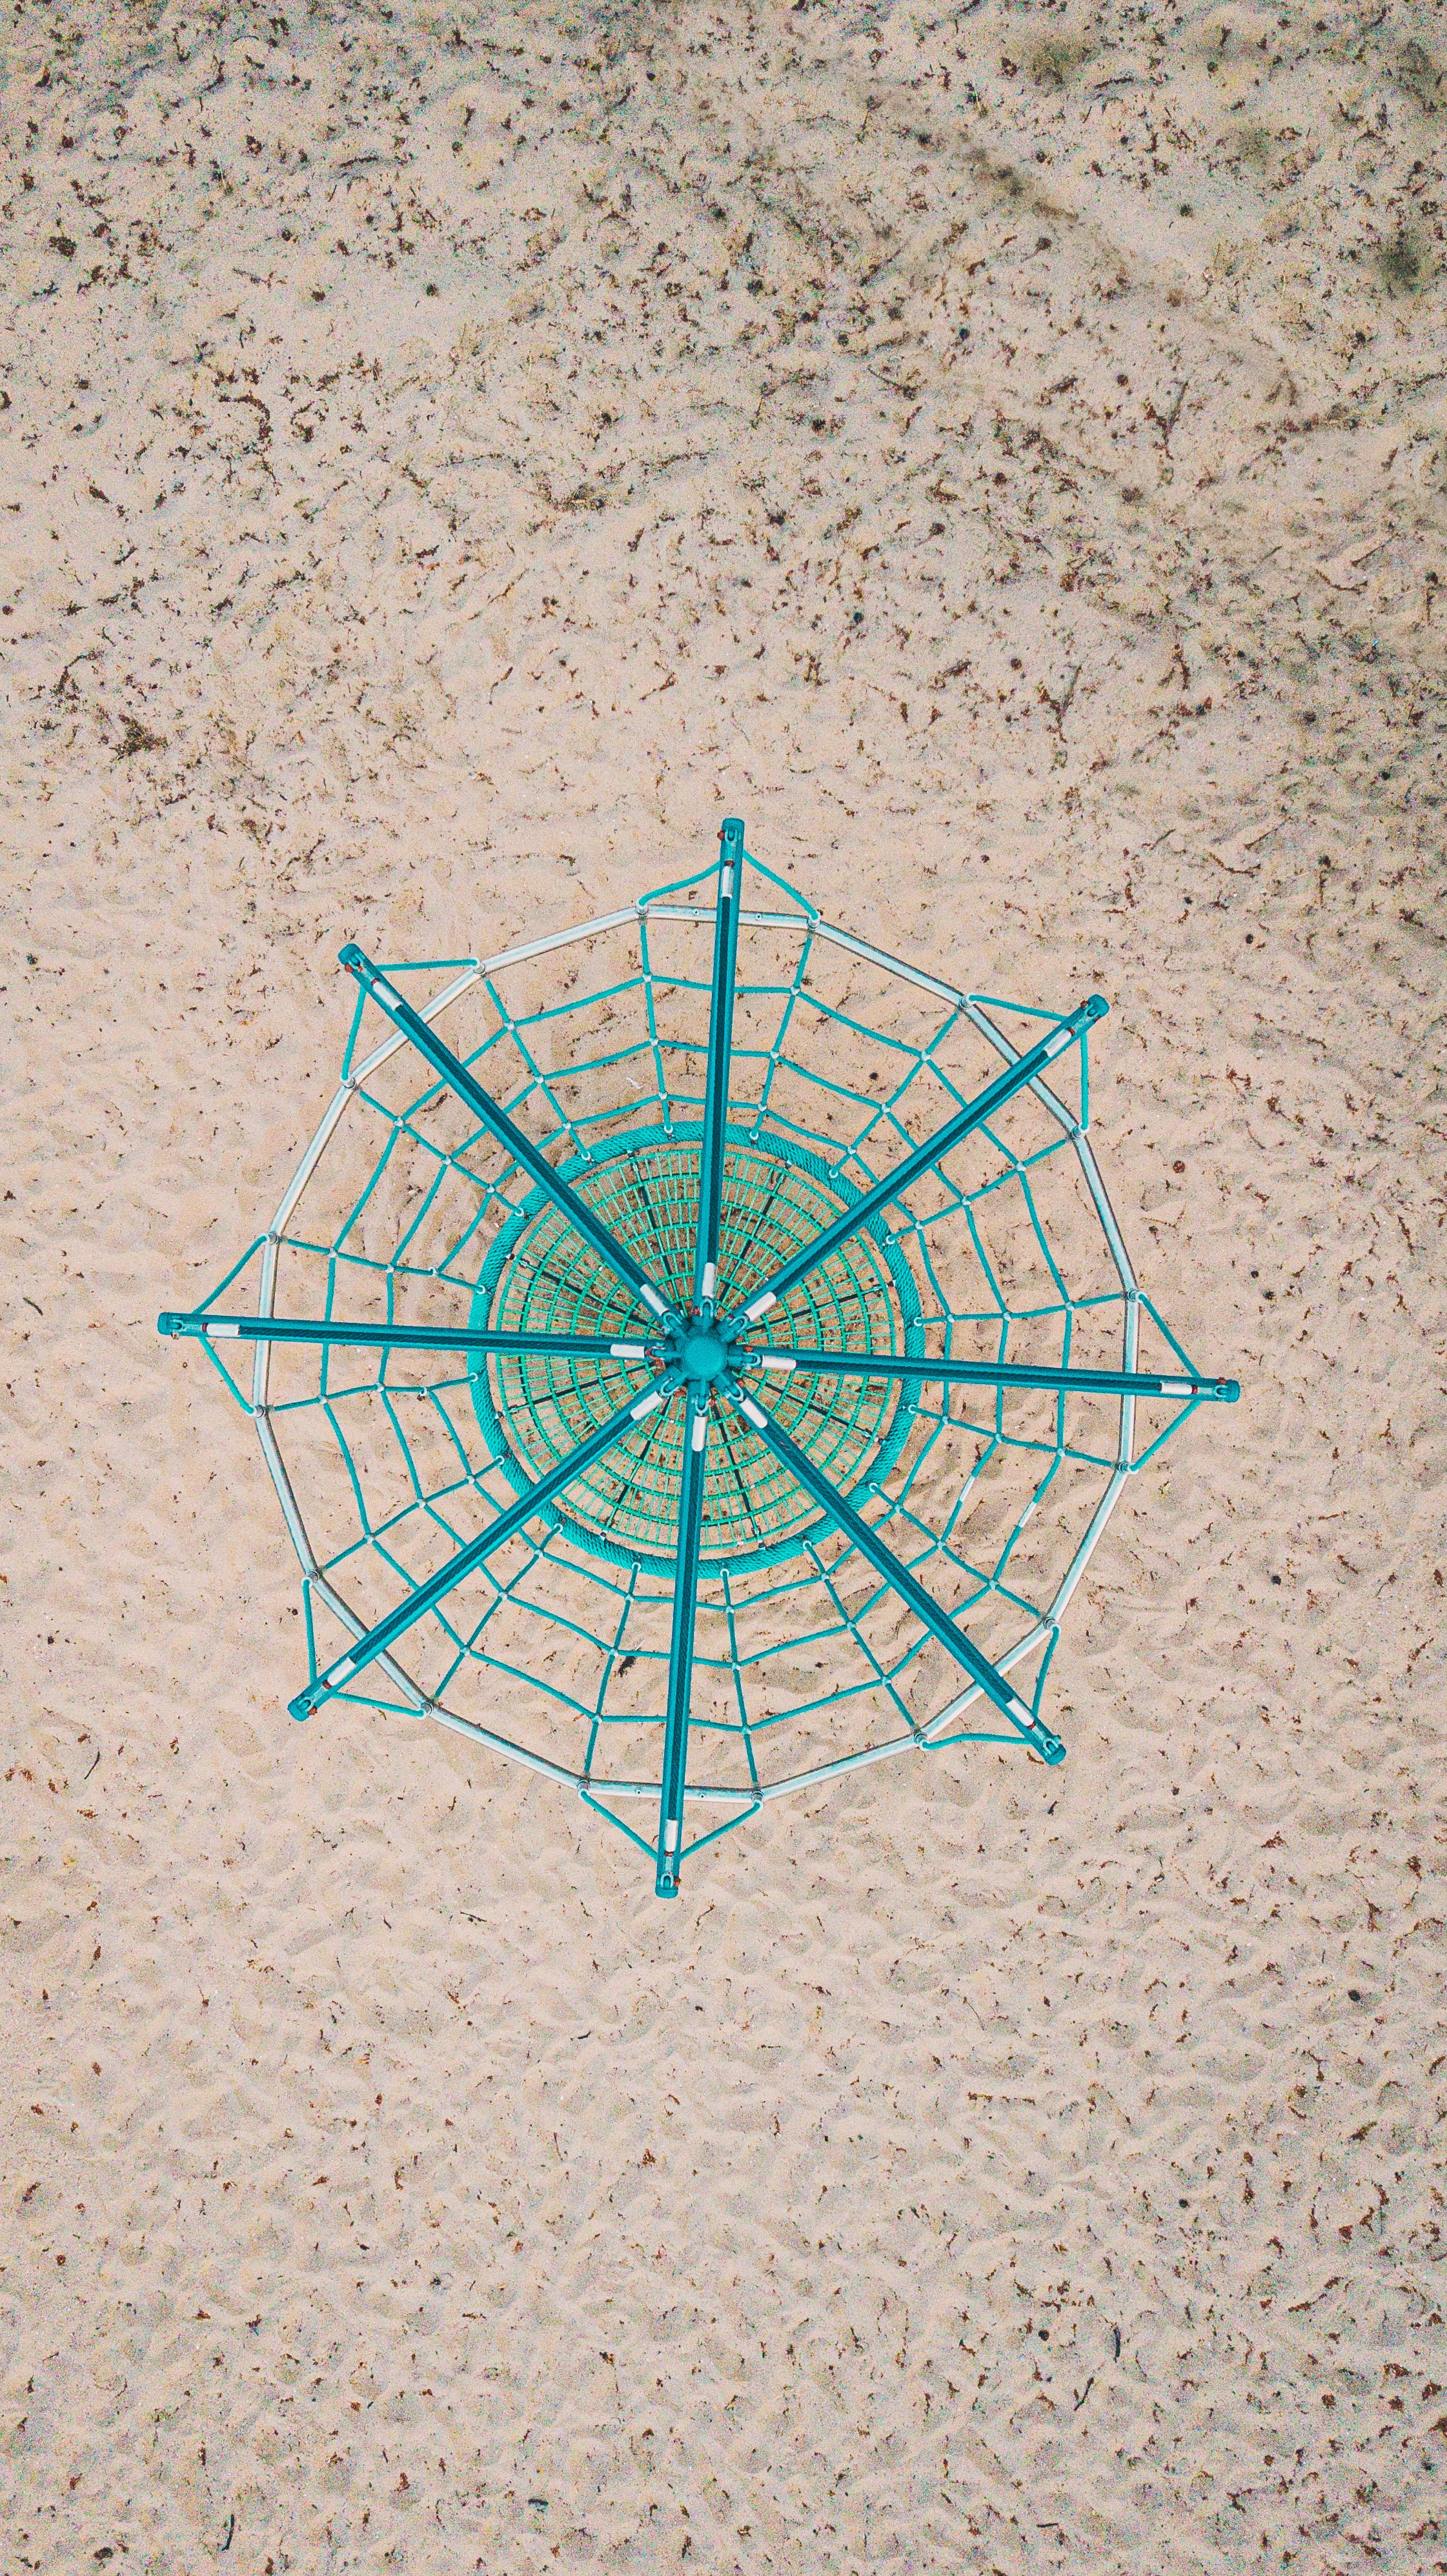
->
xmin=157 ymin=819 xmax=1239 ymax=1896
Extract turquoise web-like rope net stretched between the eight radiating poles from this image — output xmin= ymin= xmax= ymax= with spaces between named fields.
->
xmin=180 ymin=860 xmax=1215 ymax=1852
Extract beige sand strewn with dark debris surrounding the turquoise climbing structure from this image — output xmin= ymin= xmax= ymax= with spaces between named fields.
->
xmin=0 ymin=0 xmax=1447 ymax=2576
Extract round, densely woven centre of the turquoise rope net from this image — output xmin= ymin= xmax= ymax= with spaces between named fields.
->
xmin=471 ymin=1128 xmax=924 ymax=1571
